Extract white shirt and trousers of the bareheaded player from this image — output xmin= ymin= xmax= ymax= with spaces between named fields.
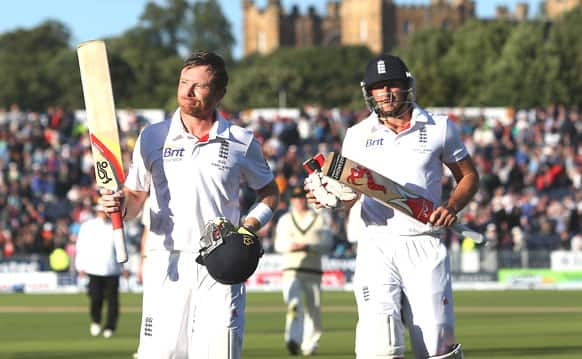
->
xmin=125 ymin=110 xmax=273 ymax=359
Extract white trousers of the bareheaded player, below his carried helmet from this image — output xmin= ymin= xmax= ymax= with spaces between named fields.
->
xmin=138 ymin=250 xmax=245 ymax=359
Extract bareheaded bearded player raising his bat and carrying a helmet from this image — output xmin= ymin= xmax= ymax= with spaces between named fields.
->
xmin=101 ymin=51 xmax=279 ymax=359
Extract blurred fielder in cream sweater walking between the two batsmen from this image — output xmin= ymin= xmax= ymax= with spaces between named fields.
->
xmin=275 ymin=186 xmax=333 ymax=355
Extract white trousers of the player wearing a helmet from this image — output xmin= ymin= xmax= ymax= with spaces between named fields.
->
xmin=354 ymin=232 xmax=455 ymax=359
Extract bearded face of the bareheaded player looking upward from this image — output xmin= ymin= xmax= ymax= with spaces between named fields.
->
xmin=178 ymin=66 xmax=224 ymax=118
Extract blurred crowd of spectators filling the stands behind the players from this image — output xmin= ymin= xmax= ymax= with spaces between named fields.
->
xmin=0 ymin=105 xmax=582 ymax=266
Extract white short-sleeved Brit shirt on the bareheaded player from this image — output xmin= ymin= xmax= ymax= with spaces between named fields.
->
xmin=125 ymin=109 xmax=273 ymax=252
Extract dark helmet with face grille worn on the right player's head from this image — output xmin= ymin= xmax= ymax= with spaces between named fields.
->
xmin=360 ymin=54 xmax=416 ymax=117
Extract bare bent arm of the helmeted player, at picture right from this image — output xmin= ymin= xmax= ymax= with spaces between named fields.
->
xmin=430 ymin=155 xmax=479 ymax=227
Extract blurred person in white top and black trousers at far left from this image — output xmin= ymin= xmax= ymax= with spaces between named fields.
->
xmin=75 ymin=205 xmax=123 ymax=338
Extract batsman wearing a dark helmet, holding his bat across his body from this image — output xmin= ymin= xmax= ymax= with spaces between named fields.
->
xmin=306 ymin=55 xmax=479 ymax=359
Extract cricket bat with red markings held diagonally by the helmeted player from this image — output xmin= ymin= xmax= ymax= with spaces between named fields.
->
xmin=303 ymin=152 xmax=485 ymax=243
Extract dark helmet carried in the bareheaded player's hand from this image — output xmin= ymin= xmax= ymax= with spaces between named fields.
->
xmin=196 ymin=218 xmax=263 ymax=284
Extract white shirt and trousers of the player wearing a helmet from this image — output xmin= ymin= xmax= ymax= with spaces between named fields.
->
xmin=342 ymin=105 xmax=468 ymax=358
